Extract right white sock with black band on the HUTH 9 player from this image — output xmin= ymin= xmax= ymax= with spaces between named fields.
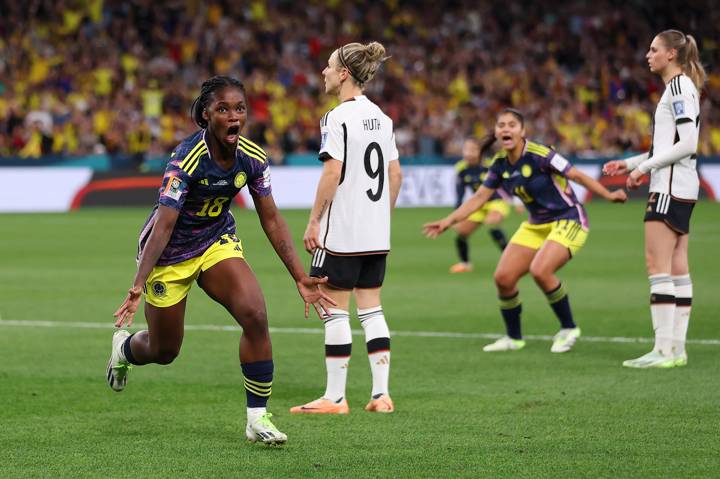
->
xmin=358 ymin=306 xmax=390 ymax=398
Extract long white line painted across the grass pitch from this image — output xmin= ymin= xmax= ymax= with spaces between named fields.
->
xmin=0 ymin=319 xmax=720 ymax=346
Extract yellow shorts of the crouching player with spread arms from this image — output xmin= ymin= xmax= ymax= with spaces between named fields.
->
xmin=510 ymin=220 xmax=588 ymax=256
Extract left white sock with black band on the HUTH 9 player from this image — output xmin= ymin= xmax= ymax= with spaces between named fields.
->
xmin=323 ymin=308 xmax=352 ymax=401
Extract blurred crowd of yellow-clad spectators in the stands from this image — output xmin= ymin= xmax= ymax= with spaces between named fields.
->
xmin=0 ymin=0 xmax=720 ymax=163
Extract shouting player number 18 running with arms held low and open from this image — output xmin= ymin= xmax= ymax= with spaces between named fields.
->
xmin=107 ymin=76 xmax=334 ymax=444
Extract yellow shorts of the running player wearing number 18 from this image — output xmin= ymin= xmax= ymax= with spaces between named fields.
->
xmin=145 ymin=234 xmax=245 ymax=308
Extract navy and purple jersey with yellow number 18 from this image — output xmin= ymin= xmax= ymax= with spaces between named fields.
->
xmin=138 ymin=130 xmax=272 ymax=266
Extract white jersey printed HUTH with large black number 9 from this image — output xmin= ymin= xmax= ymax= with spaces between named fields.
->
xmin=320 ymin=95 xmax=399 ymax=255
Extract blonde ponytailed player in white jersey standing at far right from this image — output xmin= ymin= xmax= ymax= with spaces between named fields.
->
xmin=603 ymin=30 xmax=705 ymax=369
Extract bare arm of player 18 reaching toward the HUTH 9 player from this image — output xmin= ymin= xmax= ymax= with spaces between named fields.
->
xmin=253 ymin=191 xmax=335 ymax=318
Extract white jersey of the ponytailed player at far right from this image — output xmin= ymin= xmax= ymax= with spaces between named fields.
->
xmin=648 ymin=74 xmax=700 ymax=200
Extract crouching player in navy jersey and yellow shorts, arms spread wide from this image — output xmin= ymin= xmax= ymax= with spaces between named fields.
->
xmin=423 ymin=108 xmax=627 ymax=353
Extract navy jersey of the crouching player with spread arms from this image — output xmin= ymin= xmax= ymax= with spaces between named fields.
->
xmin=483 ymin=141 xmax=589 ymax=229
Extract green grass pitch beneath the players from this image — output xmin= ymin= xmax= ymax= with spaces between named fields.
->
xmin=0 ymin=202 xmax=720 ymax=478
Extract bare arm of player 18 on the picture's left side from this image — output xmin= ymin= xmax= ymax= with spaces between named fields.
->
xmin=113 ymin=205 xmax=180 ymax=328
